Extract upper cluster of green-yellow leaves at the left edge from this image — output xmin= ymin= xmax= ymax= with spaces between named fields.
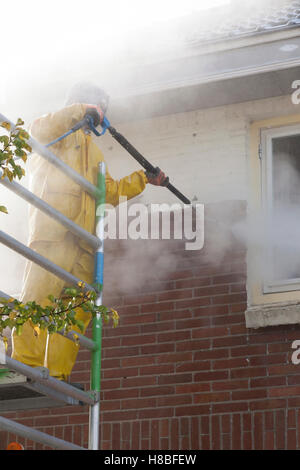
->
xmin=0 ymin=119 xmax=32 ymax=214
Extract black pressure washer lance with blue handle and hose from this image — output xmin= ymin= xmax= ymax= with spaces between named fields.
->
xmin=46 ymin=109 xmax=191 ymax=204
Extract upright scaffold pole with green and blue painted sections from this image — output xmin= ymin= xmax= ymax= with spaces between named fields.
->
xmin=89 ymin=162 xmax=106 ymax=450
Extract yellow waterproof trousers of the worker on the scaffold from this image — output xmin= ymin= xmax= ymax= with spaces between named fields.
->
xmin=12 ymin=232 xmax=94 ymax=380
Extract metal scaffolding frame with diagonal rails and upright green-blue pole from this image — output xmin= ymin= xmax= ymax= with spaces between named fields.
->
xmin=0 ymin=113 xmax=106 ymax=450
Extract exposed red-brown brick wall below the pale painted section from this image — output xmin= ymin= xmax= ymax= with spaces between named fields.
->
xmin=0 ymin=200 xmax=300 ymax=450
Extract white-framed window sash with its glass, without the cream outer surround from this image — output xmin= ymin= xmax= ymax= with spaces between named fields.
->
xmin=261 ymin=125 xmax=300 ymax=293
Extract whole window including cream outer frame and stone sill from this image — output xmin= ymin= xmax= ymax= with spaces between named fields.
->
xmin=245 ymin=115 xmax=300 ymax=328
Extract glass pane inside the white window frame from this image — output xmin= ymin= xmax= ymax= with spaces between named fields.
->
xmin=270 ymin=135 xmax=300 ymax=280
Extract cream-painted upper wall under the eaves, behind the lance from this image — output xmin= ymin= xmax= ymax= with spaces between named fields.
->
xmin=98 ymin=96 xmax=298 ymax=203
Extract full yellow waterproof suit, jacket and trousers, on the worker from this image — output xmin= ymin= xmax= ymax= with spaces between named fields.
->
xmin=12 ymin=104 xmax=147 ymax=380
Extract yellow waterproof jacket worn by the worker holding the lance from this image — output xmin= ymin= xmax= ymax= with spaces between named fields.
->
xmin=29 ymin=104 xmax=147 ymax=243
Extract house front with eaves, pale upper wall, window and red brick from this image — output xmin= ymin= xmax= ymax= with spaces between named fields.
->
xmin=0 ymin=1 xmax=300 ymax=450
